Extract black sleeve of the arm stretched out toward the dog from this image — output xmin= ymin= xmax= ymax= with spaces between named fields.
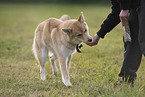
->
xmin=97 ymin=0 xmax=120 ymax=38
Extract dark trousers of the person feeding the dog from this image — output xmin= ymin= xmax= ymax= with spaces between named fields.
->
xmin=119 ymin=0 xmax=145 ymax=79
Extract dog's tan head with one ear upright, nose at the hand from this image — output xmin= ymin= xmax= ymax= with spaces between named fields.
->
xmin=62 ymin=12 xmax=92 ymax=44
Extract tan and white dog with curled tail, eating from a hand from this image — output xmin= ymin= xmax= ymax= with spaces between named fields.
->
xmin=33 ymin=13 xmax=92 ymax=86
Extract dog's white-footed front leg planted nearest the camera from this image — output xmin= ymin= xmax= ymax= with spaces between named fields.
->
xmin=58 ymin=57 xmax=72 ymax=87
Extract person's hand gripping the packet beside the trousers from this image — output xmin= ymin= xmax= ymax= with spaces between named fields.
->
xmin=119 ymin=10 xmax=129 ymax=24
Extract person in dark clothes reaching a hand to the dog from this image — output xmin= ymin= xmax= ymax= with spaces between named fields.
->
xmin=87 ymin=0 xmax=145 ymax=85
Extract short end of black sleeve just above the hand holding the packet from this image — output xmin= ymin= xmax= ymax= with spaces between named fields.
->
xmin=118 ymin=0 xmax=131 ymax=10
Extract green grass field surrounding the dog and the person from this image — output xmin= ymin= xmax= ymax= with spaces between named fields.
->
xmin=0 ymin=3 xmax=145 ymax=97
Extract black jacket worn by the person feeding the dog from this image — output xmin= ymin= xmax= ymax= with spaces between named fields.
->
xmin=97 ymin=0 xmax=140 ymax=38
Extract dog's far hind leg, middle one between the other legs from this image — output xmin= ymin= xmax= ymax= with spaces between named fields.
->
xmin=48 ymin=52 xmax=58 ymax=76
